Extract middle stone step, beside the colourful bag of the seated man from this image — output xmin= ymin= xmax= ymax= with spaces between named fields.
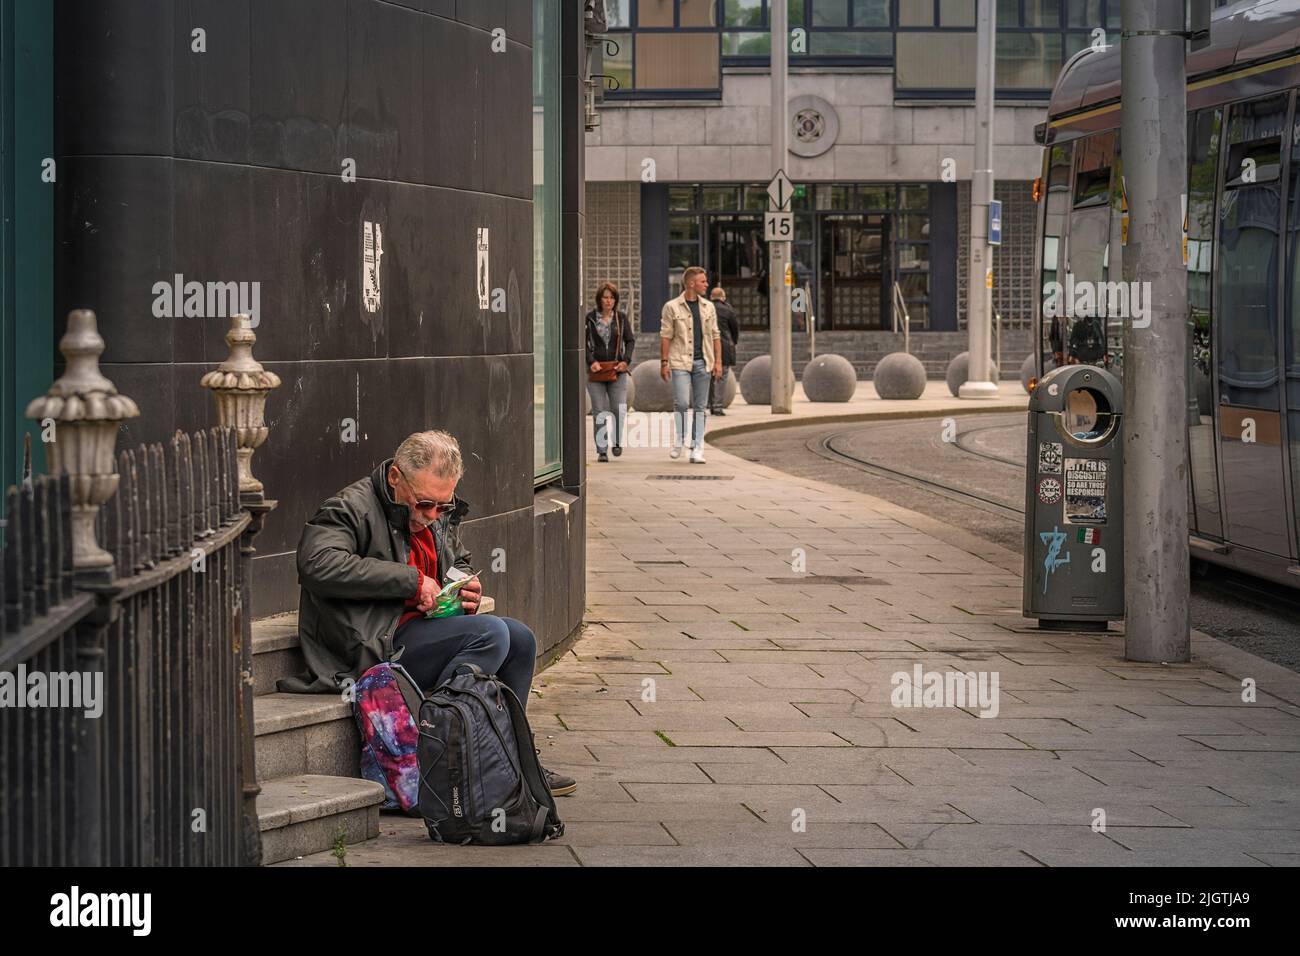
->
xmin=252 ymin=693 xmax=361 ymax=780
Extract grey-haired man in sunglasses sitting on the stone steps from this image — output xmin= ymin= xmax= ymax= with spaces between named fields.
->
xmin=295 ymin=432 xmax=577 ymax=795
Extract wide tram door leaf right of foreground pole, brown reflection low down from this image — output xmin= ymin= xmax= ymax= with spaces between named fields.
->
xmin=1214 ymin=95 xmax=1291 ymax=555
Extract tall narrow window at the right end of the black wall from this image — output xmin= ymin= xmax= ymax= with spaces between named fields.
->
xmin=533 ymin=0 xmax=563 ymax=483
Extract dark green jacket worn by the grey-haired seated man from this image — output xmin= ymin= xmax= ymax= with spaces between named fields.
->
xmin=277 ymin=459 xmax=473 ymax=693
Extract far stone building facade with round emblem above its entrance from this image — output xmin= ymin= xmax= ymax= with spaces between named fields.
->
xmin=586 ymin=0 xmax=1138 ymax=372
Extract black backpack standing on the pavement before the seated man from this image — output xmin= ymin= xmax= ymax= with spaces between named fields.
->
xmin=416 ymin=663 xmax=564 ymax=845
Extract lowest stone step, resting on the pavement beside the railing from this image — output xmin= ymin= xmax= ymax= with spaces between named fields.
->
xmin=257 ymin=774 xmax=384 ymax=865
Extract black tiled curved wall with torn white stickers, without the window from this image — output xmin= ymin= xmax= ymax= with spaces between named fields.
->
xmin=48 ymin=0 xmax=581 ymax=645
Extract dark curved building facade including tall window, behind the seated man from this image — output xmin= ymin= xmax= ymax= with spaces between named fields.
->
xmin=0 ymin=0 xmax=585 ymax=658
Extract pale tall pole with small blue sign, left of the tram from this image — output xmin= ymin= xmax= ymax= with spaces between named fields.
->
xmin=957 ymin=0 xmax=997 ymax=398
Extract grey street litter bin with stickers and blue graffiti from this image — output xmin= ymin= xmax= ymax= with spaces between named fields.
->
xmin=1023 ymin=365 xmax=1125 ymax=631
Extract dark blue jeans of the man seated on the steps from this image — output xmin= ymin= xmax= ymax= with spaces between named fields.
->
xmin=393 ymin=614 xmax=537 ymax=710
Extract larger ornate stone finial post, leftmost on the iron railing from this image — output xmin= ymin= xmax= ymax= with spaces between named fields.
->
xmin=26 ymin=308 xmax=140 ymax=571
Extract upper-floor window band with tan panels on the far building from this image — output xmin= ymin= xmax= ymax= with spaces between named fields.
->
xmin=605 ymin=0 xmax=1149 ymax=99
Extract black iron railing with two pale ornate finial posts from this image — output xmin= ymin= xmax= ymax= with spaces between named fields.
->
xmin=0 ymin=311 xmax=280 ymax=866
